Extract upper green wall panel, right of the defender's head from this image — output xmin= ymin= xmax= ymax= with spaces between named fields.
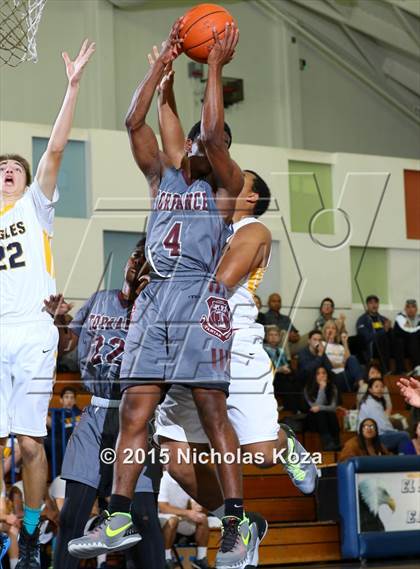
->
xmin=289 ymin=160 xmax=334 ymax=234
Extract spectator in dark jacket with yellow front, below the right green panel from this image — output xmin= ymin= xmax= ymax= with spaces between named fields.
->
xmin=356 ymin=294 xmax=391 ymax=373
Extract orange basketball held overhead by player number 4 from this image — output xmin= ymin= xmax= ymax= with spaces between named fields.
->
xmin=179 ymin=4 xmax=236 ymax=63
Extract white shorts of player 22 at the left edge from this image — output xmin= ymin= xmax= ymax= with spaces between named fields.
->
xmin=0 ymin=319 xmax=58 ymax=437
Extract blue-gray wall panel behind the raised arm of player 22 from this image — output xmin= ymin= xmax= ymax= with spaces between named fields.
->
xmin=32 ymin=137 xmax=88 ymax=218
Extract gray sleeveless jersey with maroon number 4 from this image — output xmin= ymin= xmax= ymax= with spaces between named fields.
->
xmin=146 ymin=168 xmax=232 ymax=277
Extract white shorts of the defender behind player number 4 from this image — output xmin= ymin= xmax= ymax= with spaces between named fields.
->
xmin=156 ymin=329 xmax=279 ymax=445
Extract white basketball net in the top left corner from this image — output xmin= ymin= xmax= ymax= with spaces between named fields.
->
xmin=0 ymin=0 xmax=47 ymax=67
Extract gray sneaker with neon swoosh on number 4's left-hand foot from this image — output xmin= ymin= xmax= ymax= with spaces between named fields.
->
xmin=68 ymin=511 xmax=141 ymax=559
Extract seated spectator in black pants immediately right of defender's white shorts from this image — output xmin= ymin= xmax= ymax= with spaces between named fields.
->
xmin=264 ymin=326 xmax=306 ymax=413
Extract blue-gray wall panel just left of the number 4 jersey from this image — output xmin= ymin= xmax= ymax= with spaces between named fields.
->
xmin=103 ymin=231 xmax=145 ymax=290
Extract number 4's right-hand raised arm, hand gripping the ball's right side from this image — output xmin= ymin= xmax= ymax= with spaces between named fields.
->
xmin=201 ymin=24 xmax=244 ymax=197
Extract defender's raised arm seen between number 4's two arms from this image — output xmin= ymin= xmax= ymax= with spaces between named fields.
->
xmin=148 ymin=46 xmax=185 ymax=168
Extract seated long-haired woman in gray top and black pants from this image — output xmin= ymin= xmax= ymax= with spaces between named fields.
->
xmin=304 ymin=365 xmax=341 ymax=450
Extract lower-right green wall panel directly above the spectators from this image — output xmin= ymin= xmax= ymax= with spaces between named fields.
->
xmin=350 ymin=247 xmax=388 ymax=304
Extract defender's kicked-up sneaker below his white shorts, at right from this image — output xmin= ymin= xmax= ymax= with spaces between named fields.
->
xmin=280 ymin=423 xmax=318 ymax=494
